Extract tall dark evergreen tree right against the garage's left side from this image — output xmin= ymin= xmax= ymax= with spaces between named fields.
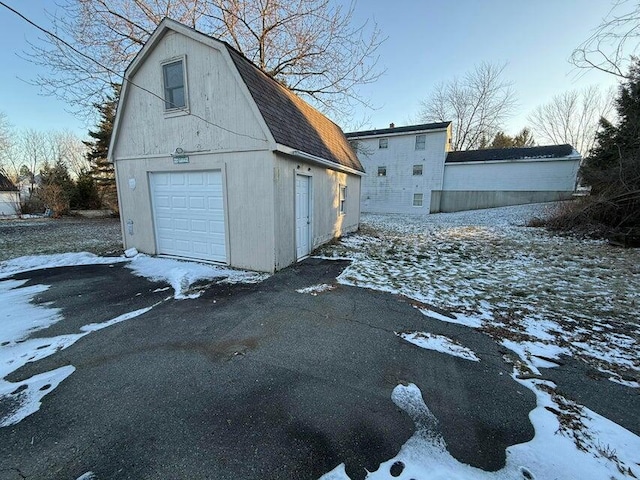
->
xmin=84 ymin=85 xmax=120 ymax=212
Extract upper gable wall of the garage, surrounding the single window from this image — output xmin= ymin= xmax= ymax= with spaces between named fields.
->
xmin=112 ymin=32 xmax=272 ymax=159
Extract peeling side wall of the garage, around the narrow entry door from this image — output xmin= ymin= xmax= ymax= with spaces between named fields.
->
xmin=273 ymin=155 xmax=360 ymax=269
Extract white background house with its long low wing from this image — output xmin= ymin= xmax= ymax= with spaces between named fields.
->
xmin=347 ymin=122 xmax=581 ymax=214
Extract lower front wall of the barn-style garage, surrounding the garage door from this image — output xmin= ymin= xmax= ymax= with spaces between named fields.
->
xmin=115 ymin=151 xmax=274 ymax=272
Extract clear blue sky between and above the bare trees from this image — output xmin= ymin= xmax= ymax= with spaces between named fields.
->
xmin=0 ymin=0 xmax=616 ymax=136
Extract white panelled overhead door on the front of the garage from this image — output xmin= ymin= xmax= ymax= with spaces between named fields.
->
xmin=150 ymin=170 xmax=227 ymax=262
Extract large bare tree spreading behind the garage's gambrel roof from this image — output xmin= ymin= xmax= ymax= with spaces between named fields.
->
xmin=23 ymin=0 xmax=384 ymax=122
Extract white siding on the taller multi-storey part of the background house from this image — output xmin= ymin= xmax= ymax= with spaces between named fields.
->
xmin=356 ymin=130 xmax=449 ymax=214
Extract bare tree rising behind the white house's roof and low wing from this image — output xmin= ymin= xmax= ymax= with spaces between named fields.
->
xmin=420 ymin=62 xmax=516 ymax=150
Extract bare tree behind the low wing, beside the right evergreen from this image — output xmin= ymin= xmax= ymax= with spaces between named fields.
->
xmin=528 ymin=86 xmax=613 ymax=157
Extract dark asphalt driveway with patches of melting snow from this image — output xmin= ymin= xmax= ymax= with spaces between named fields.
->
xmin=0 ymin=259 xmax=535 ymax=480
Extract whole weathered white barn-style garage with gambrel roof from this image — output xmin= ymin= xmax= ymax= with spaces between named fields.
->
xmin=109 ymin=19 xmax=364 ymax=272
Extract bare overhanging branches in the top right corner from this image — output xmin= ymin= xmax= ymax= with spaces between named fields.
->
xmin=570 ymin=0 xmax=640 ymax=78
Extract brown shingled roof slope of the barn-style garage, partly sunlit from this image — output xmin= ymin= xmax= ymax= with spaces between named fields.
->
xmin=225 ymin=47 xmax=364 ymax=172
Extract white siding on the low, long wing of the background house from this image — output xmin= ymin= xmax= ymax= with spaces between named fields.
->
xmin=442 ymin=159 xmax=580 ymax=192
